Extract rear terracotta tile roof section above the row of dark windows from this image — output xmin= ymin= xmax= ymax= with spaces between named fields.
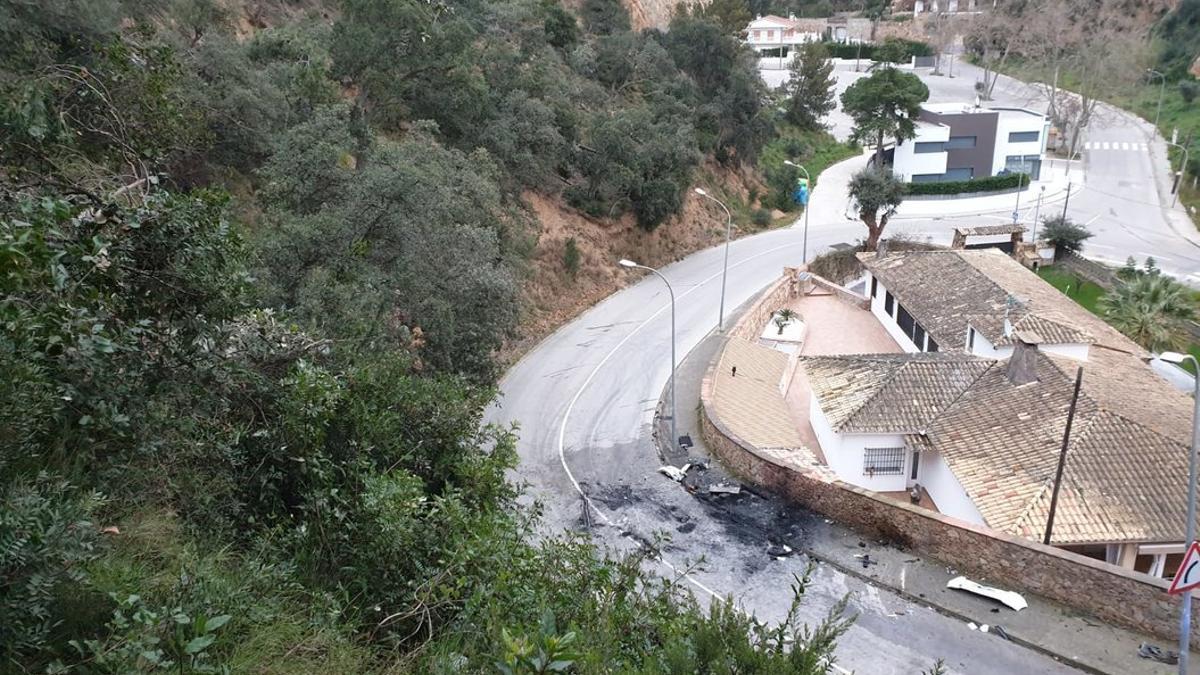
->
xmin=859 ymin=249 xmax=1145 ymax=356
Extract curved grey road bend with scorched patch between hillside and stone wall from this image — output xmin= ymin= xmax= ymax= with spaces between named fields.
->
xmin=486 ymin=223 xmax=1074 ymax=675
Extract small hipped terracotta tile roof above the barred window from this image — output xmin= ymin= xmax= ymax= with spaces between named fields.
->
xmin=802 ymin=352 xmax=995 ymax=434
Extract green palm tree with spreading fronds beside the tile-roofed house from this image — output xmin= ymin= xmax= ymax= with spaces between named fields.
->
xmin=1099 ymin=274 xmax=1196 ymax=352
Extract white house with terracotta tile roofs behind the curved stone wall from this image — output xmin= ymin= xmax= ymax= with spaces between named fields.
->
xmin=802 ymin=250 xmax=1192 ymax=577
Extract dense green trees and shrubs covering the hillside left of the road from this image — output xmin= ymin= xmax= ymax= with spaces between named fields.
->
xmin=0 ymin=0 xmax=846 ymax=674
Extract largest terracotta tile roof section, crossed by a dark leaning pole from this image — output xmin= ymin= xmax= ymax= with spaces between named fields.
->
xmin=926 ymin=353 xmax=1190 ymax=544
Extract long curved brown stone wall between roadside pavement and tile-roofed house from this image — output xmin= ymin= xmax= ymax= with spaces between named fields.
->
xmin=700 ymin=270 xmax=1200 ymax=640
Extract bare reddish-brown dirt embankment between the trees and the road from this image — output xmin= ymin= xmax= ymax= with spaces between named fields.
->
xmin=500 ymin=163 xmax=758 ymax=363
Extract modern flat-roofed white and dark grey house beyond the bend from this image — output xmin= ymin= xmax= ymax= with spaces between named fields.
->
xmin=892 ymin=103 xmax=1050 ymax=183
